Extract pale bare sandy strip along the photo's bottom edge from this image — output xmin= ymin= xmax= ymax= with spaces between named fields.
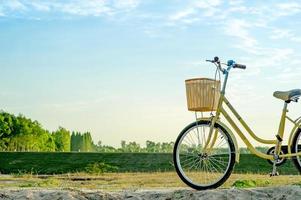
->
xmin=0 ymin=186 xmax=301 ymax=200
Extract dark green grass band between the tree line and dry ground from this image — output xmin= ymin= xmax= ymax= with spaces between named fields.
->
xmin=0 ymin=152 xmax=298 ymax=174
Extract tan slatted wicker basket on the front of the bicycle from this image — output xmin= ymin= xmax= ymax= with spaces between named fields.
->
xmin=185 ymin=78 xmax=221 ymax=112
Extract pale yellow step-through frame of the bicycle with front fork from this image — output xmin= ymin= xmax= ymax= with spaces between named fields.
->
xmin=203 ymin=67 xmax=301 ymax=162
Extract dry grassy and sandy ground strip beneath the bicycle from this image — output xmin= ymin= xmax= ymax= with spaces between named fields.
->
xmin=0 ymin=172 xmax=301 ymax=200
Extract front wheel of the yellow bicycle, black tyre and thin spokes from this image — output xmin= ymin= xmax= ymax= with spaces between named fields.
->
xmin=173 ymin=120 xmax=235 ymax=190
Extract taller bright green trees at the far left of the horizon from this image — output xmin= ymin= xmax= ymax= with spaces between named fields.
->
xmin=0 ymin=111 xmax=94 ymax=152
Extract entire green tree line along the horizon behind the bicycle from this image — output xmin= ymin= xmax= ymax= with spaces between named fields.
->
xmin=0 ymin=111 xmax=268 ymax=153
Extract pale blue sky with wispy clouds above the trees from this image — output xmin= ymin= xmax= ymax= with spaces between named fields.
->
xmin=0 ymin=0 xmax=301 ymax=146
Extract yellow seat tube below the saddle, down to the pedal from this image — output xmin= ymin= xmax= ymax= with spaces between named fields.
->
xmin=270 ymin=102 xmax=288 ymax=176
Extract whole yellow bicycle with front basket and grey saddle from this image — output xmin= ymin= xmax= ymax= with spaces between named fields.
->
xmin=173 ymin=57 xmax=301 ymax=190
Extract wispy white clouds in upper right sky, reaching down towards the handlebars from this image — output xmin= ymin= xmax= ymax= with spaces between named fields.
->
xmin=164 ymin=1 xmax=301 ymax=82
